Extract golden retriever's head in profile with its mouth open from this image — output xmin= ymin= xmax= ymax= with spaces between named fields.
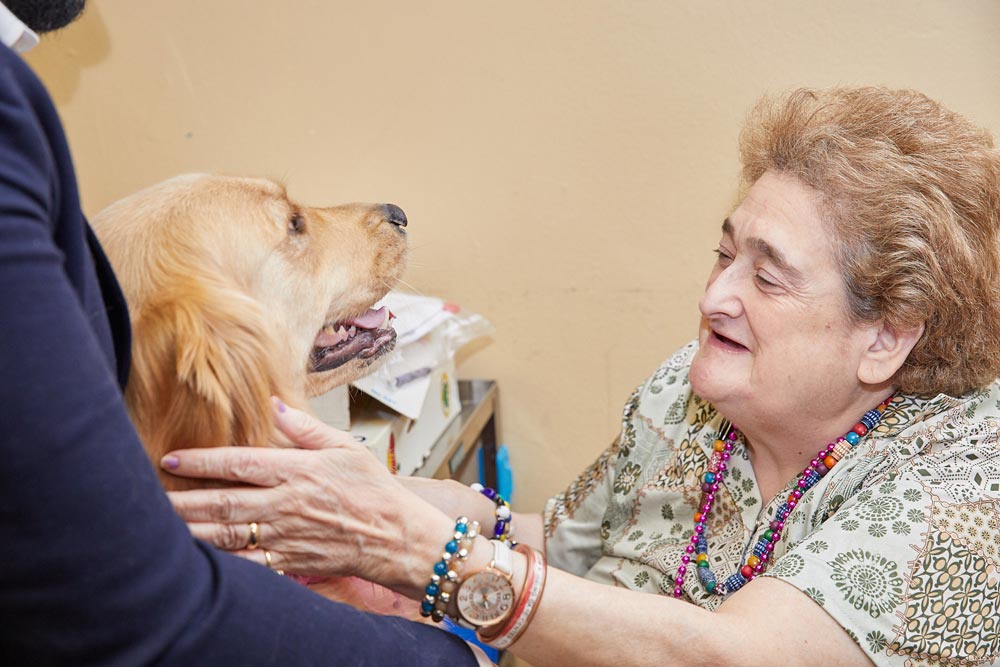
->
xmin=93 ymin=175 xmax=406 ymax=488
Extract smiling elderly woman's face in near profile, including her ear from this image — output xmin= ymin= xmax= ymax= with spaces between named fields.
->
xmin=691 ymin=172 xmax=872 ymax=425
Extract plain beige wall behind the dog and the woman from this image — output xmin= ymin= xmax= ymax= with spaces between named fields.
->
xmin=28 ymin=0 xmax=1000 ymax=509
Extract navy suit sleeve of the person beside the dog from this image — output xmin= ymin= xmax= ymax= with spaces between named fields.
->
xmin=0 ymin=48 xmax=475 ymax=665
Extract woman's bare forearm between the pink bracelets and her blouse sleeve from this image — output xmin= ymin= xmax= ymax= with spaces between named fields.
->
xmin=498 ymin=554 xmax=871 ymax=667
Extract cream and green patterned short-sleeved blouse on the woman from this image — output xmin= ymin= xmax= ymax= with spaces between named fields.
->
xmin=545 ymin=343 xmax=1000 ymax=667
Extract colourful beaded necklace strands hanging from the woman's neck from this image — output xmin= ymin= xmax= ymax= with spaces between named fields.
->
xmin=674 ymin=396 xmax=892 ymax=598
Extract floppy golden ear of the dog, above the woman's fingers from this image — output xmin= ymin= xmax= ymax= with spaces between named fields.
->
xmin=126 ymin=274 xmax=300 ymax=488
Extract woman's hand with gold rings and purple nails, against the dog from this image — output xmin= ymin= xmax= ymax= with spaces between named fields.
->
xmin=161 ymin=399 xmax=454 ymax=597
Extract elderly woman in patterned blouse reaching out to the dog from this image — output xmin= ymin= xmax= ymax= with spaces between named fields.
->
xmin=163 ymin=88 xmax=1000 ymax=665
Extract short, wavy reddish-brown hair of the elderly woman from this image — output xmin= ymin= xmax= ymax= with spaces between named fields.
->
xmin=740 ymin=87 xmax=1000 ymax=396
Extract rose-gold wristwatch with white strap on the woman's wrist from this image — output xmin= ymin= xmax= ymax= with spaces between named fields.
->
xmin=455 ymin=540 xmax=514 ymax=629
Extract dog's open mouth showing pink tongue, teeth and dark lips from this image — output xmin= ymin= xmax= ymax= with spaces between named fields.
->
xmin=309 ymin=306 xmax=396 ymax=373
